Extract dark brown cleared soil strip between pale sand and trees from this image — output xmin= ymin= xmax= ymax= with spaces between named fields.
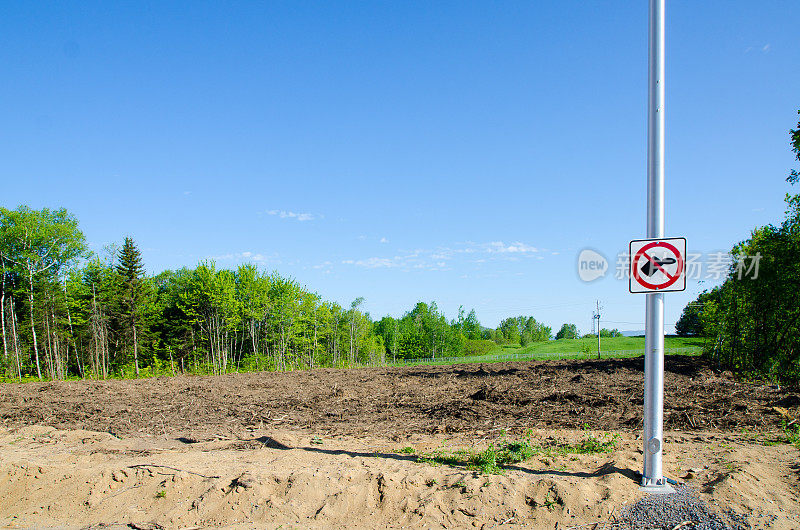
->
xmin=0 ymin=356 xmax=800 ymax=439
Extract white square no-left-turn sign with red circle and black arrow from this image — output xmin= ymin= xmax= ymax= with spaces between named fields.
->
xmin=628 ymin=237 xmax=686 ymax=293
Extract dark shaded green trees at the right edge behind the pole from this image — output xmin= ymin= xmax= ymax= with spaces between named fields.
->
xmin=675 ymin=111 xmax=800 ymax=381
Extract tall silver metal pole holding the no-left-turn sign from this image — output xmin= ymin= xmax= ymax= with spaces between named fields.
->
xmin=642 ymin=0 xmax=672 ymax=492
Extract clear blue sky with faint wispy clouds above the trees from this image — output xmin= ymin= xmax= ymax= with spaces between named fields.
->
xmin=0 ymin=0 xmax=800 ymax=331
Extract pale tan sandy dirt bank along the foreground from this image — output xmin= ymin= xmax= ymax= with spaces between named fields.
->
xmin=0 ymin=426 xmax=800 ymax=529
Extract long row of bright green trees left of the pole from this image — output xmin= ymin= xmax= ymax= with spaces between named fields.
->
xmin=0 ymin=206 xmax=577 ymax=380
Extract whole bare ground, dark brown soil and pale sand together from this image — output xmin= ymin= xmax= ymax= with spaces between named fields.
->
xmin=0 ymin=356 xmax=800 ymax=529
